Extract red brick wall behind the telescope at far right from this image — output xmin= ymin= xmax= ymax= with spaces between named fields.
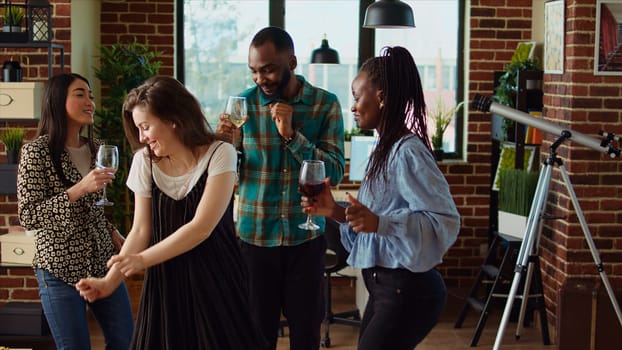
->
xmin=540 ymin=0 xmax=622 ymax=324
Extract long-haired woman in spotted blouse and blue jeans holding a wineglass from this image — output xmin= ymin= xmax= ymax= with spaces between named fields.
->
xmin=17 ymin=74 xmax=134 ymax=350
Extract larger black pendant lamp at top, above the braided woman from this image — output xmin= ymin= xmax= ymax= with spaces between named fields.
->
xmin=363 ymin=0 xmax=415 ymax=28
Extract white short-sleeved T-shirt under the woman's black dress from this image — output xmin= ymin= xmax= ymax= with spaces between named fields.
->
xmin=126 ymin=141 xmax=237 ymax=200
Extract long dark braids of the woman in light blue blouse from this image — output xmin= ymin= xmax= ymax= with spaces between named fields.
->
xmin=360 ymin=46 xmax=432 ymax=186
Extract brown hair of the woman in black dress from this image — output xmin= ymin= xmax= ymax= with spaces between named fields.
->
xmin=123 ymin=76 xmax=219 ymax=161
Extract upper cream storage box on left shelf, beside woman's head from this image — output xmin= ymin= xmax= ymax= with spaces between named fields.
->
xmin=0 ymin=82 xmax=44 ymax=119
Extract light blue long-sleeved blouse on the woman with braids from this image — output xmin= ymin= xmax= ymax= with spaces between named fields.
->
xmin=339 ymin=135 xmax=460 ymax=272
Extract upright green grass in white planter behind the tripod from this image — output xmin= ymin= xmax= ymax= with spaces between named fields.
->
xmin=499 ymin=169 xmax=538 ymax=216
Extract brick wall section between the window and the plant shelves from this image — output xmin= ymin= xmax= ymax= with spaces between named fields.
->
xmin=440 ymin=0 xmax=532 ymax=289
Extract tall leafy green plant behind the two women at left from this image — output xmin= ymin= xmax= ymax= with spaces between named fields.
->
xmin=95 ymin=39 xmax=162 ymax=232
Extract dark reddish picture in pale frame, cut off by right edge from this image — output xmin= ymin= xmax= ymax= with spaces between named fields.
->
xmin=594 ymin=0 xmax=622 ymax=75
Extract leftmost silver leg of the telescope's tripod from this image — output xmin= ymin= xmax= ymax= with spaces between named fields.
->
xmin=493 ymin=163 xmax=552 ymax=350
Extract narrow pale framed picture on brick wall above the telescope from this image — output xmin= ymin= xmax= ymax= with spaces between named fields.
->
xmin=544 ymin=0 xmax=564 ymax=74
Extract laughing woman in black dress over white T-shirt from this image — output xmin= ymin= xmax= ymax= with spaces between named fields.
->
xmin=76 ymin=76 xmax=265 ymax=350
